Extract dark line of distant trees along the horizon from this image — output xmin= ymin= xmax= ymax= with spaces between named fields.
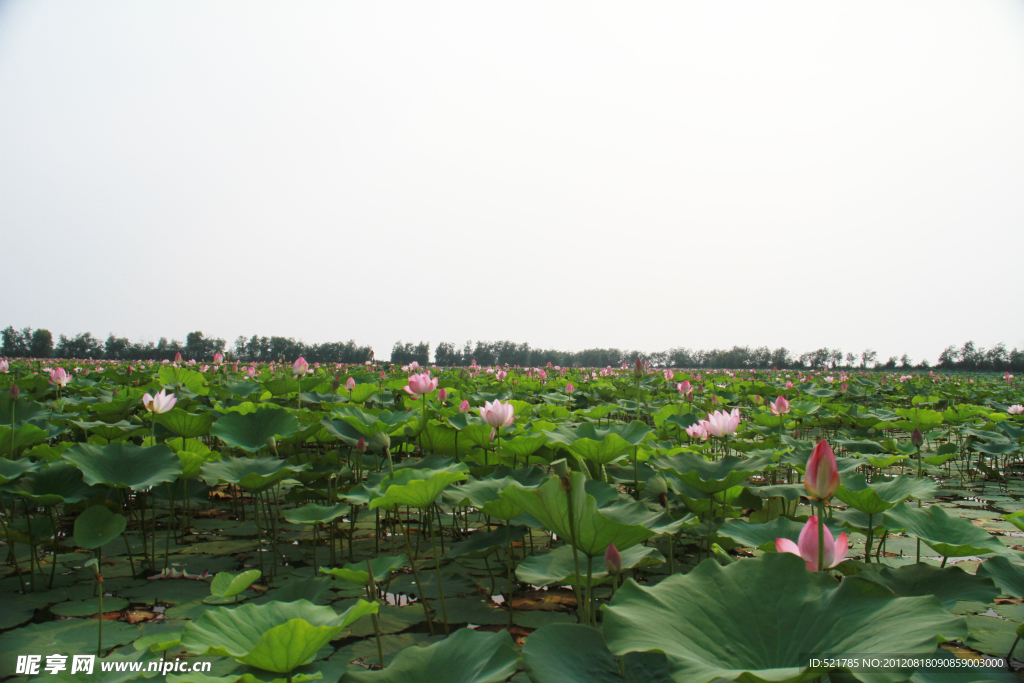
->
xmin=0 ymin=327 xmax=1024 ymax=372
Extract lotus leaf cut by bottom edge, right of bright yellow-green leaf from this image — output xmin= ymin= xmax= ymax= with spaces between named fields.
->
xmin=341 ymin=629 xmax=519 ymax=683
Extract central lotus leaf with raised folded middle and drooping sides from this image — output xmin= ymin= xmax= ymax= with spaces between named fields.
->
xmin=502 ymin=472 xmax=655 ymax=557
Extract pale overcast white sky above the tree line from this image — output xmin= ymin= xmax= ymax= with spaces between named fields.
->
xmin=0 ymin=0 xmax=1024 ymax=362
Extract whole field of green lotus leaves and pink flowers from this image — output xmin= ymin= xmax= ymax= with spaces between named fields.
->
xmin=0 ymin=354 xmax=1024 ymax=683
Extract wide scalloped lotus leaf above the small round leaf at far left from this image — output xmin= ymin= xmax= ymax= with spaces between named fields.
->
xmin=63 ymin=441 xmax=181 ymax=490
